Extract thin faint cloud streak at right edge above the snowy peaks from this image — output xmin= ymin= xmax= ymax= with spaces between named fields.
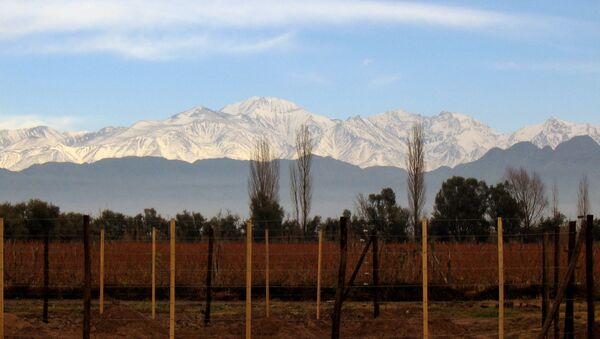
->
xmin=492 ymin=61 xmax=600 ymax=74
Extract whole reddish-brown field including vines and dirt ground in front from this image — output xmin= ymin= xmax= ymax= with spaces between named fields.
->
xmin=5 ymin=240 xmax=600 ymax=338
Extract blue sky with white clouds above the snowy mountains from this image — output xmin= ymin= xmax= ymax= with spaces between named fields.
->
xmin=0 ymin=0 xmax=600 ymax=132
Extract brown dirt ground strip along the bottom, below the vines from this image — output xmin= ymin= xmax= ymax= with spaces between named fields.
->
xmin=5 ymin=300 xmax=600 ymax=338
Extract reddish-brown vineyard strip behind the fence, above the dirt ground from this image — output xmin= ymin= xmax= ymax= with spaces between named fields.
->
xmin=5 ymin=241 xmax=600 ymax=294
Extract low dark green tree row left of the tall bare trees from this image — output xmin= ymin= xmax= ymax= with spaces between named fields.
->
xmin=0 ymin=199 xmax=244 ymax=241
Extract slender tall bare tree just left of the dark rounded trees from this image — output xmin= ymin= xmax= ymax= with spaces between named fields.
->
xmin=406 ymin=122 xmax=425 ymax=239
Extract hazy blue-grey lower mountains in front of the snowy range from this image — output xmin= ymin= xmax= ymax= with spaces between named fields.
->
xmin=0 ymin=136 xmax=600 ymax=217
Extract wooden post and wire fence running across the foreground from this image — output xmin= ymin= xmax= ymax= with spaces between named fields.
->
xmin=0 ymin=217 xmax=594 ymax=338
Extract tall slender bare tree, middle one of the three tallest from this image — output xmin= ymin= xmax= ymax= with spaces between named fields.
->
xmin=290 ymin=124 xmax=313 ymax=236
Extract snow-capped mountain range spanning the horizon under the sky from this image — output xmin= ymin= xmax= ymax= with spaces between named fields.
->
xmin=0 ymin=97 xmax=600 ymax=170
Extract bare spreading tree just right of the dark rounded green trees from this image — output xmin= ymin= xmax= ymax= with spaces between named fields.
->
xmin=505 ymin=167 xmax=548 ymax=230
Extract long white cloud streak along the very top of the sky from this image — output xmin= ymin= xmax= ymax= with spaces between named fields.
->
xmin=0 ymin=0 xmax=525 ymax=37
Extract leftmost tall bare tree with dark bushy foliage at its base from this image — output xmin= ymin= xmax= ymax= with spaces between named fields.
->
xmin=248 ymin=140 xmax=283 ymax=232
